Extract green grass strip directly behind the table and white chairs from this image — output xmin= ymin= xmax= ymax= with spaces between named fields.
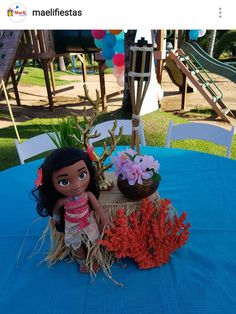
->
xmin=0 ymin=110 xmax=236 ymax=170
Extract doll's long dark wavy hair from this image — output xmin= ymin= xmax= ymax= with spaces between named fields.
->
xmin=32 ymin=147 xmax=100 ymax=221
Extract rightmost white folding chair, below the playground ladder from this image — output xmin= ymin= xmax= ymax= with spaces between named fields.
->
xmin=166 ymin=121 xmax=234 ymax=157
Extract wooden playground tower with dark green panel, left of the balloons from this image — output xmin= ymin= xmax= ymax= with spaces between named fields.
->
xmin=0 ymin=30 xmax=110 ymax=110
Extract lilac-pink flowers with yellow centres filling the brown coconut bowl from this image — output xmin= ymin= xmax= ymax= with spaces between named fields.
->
xmin=112 ymin=149 xmax=161 ymax=185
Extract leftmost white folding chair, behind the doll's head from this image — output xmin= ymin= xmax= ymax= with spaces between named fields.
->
xmin=15 ymin=132 xmax=57 ymax=164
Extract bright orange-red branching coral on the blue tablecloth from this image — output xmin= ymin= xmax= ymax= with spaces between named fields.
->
xmin=100 ymin=199 xmax=190 ymax=269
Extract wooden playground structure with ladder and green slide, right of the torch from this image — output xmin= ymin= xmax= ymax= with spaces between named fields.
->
xmin=157 ymin=31 xmax=236 ymax=123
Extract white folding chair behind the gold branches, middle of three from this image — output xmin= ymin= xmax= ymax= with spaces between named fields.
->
xmin=89 ymin=119 xmax=146 ymax=146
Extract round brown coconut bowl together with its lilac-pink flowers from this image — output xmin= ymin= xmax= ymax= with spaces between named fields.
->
xmin=112 ymin=149 xmax=161 ymax=200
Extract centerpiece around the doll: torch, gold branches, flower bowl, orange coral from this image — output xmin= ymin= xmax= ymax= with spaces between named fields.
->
xmin=33 ymin=33 xmax=190 ymax=285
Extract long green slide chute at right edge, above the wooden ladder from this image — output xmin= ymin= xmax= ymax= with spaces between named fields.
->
xmin=181 ymin=42 xmax=236 ymax=83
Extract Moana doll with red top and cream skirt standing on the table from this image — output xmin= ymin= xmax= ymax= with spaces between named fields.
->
xmin=33 ymin=147 xmax=113 ymax=272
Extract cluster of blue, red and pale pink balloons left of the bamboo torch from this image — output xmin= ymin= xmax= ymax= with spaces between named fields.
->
xmin=91 ymin=29 xmax=125 ymax=86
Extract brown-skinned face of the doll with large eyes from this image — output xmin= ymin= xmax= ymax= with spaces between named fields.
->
xmin=52 ymin=160 xmax=90 ymax=196
